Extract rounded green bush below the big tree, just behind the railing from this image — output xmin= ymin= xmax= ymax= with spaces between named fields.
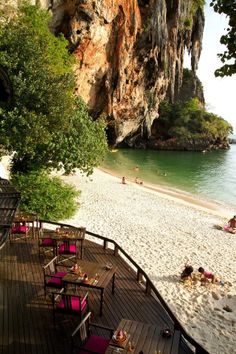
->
xmin=11 ymin=171 xmax=80 ymax=221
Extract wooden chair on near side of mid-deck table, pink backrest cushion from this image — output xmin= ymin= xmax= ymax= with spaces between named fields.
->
xmin=52 ymin=288 xmax=89 ymax=325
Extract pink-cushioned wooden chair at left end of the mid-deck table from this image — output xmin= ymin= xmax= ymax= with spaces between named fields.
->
xmin=43 ymin=256 xmax=67 ymax=297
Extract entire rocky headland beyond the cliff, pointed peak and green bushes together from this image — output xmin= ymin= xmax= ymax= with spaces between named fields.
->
xmin=149 ymin=69 xmax=233 ymax=150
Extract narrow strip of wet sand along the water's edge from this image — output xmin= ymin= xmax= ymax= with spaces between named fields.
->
xmin=98 ymin=167 xmax=235 ymax=219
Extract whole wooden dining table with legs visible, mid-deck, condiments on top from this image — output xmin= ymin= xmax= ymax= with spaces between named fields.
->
xmin=62 ymin=260 xmax=117 ymax=316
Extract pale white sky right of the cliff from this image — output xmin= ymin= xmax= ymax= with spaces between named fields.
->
xmin=186 ymin=0 xmax=236 ymax=134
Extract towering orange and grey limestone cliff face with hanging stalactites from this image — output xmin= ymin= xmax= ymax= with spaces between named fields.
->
xmin=47 ymin=0 xmax=204 ymax=145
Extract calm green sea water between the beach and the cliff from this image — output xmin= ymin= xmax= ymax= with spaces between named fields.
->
xmin=101 ymin=144 xmax=236 ymax=208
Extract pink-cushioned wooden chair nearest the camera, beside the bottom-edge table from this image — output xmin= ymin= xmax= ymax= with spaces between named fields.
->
xmin=71 ymin=312 xmax=114 ymax=354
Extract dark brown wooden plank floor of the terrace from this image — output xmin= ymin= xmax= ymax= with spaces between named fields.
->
xmin=0 ymin=234 xmax=192 ymax=354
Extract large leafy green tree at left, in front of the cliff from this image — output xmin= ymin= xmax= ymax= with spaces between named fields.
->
xmin=0 ymin=4 xmax=107 ymax=173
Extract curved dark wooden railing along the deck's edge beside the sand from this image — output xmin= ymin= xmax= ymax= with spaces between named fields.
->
xmin=39 ymin=220 xmax=209 ymax=354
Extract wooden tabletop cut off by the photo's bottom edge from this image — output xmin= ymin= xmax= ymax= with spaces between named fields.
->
xmin=105 ymin=318 xmax=180 ymax=354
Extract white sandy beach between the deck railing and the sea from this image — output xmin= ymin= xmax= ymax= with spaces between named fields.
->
xmin=59 ymin=170 xmax=236 ymax=354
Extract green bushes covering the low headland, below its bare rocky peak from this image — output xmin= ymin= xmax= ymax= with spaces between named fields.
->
xmin=152 ymin=98 xmax=232 ymax=150
